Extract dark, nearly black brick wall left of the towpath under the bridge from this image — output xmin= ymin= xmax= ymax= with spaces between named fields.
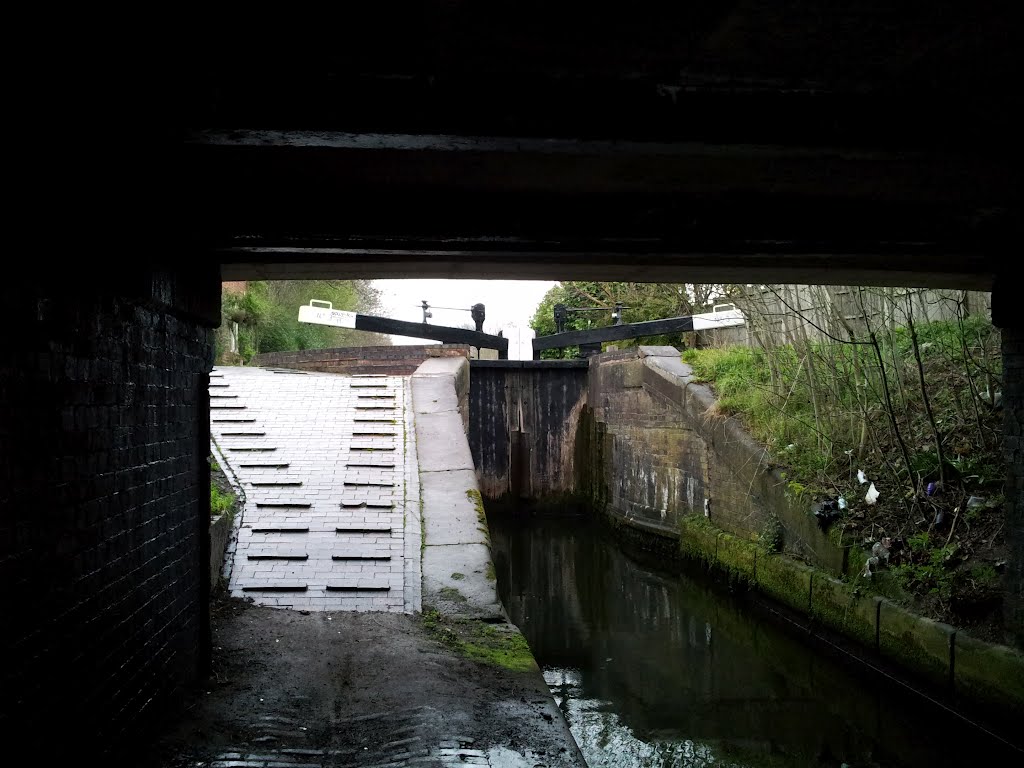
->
xmin=0 ymin=269 xmax=219 ymax=756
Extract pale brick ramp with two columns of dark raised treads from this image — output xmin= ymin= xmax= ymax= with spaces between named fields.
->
xmin=210 ymin=368 xmax=420 ymax=611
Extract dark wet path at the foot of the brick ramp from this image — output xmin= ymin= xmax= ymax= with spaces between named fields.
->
xmin=149 ymin=599 xmax=583 ymax=768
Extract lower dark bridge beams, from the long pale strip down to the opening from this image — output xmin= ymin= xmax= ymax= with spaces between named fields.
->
xmin=195 ymin=130 xmax=1013 ymax=290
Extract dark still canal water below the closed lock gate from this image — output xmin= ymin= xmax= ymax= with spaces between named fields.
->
xmin=488 ymin=514 xmax=1024 ymax=768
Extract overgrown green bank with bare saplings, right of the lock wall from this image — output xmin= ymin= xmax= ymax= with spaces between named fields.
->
xmin=682 ymin=315 xmax=1005 ymax=621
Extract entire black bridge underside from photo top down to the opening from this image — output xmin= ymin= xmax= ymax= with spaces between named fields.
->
xmin=183 ymin=0 xmax=1020 ymax=290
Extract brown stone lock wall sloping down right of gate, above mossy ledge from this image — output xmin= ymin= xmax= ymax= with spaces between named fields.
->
xmin=580 ymin=347 xmax=846 ymax=573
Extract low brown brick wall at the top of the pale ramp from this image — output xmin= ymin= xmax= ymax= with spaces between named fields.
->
xmin=252 ymin=344 xmax=469 ymax=376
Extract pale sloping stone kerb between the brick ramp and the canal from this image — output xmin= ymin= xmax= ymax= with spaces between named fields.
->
xmin=412 ymin=358 xmax=507 ymax=622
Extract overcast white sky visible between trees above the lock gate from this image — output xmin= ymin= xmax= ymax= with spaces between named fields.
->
xmin=374 ymin=280 xmax=557 ymax=360
